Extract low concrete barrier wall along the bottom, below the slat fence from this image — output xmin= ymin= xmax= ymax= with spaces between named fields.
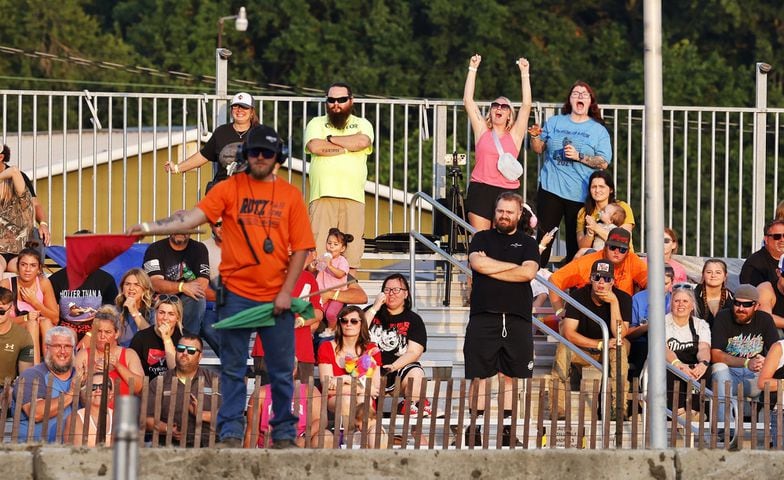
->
xmin=0 ymin=446 xmax=784 ymax=480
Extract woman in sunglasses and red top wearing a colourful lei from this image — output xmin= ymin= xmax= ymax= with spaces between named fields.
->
xmin=318 ymin=305 xmax=382 ymax=416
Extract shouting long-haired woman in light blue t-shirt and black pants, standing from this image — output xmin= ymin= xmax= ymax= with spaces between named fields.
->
xmin=528 ymin=81 xmax=612 ymax=266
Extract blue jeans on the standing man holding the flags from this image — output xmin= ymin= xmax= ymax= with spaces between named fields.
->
xmin=218 ymin=289 xmax=298 ymax=440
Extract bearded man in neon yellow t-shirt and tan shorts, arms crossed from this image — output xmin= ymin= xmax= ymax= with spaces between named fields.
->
xmin=305 ymin=83 xmax=374 ymax=272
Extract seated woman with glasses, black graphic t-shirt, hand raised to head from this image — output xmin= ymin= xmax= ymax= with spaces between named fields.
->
xmin=365 ymin=273 xmax=430 ymax=416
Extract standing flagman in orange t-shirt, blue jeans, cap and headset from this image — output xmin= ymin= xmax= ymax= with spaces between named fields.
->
xmin=128 ymin=125 xmax=315 ymax=448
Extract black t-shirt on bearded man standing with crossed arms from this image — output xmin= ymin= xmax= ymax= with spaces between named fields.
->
xmin=468 ymin=228 xmax=539 ymax=321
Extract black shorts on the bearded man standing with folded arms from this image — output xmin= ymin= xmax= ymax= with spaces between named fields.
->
xmin=463 ymin=312 xmax=534 ymax=379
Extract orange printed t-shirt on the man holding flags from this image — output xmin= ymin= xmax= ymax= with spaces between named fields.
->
xmin=197 ymin=174 xmax=316 ymax=302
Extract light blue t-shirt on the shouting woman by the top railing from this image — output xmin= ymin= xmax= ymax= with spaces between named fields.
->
xmin=539 ymin=115 xmax=612 ymax=202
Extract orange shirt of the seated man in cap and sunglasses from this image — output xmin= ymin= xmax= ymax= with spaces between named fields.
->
xmin=550 ymin=249 xmax=648 ymax=295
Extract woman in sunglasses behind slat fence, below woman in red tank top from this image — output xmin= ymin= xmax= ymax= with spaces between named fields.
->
xmin=65 ymin=374 xmax=114 ymax=447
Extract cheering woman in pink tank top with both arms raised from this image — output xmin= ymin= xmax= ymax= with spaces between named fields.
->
xmin=463 ymin=54 xmax=531 ymax=230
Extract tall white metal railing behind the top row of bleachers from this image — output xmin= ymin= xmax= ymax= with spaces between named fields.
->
xmin=0 ymin=90 xmax=784 ymax=257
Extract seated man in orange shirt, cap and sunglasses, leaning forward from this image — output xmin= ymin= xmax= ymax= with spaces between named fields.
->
xmin=550 ymin=227 xmax=648 ymax=317
